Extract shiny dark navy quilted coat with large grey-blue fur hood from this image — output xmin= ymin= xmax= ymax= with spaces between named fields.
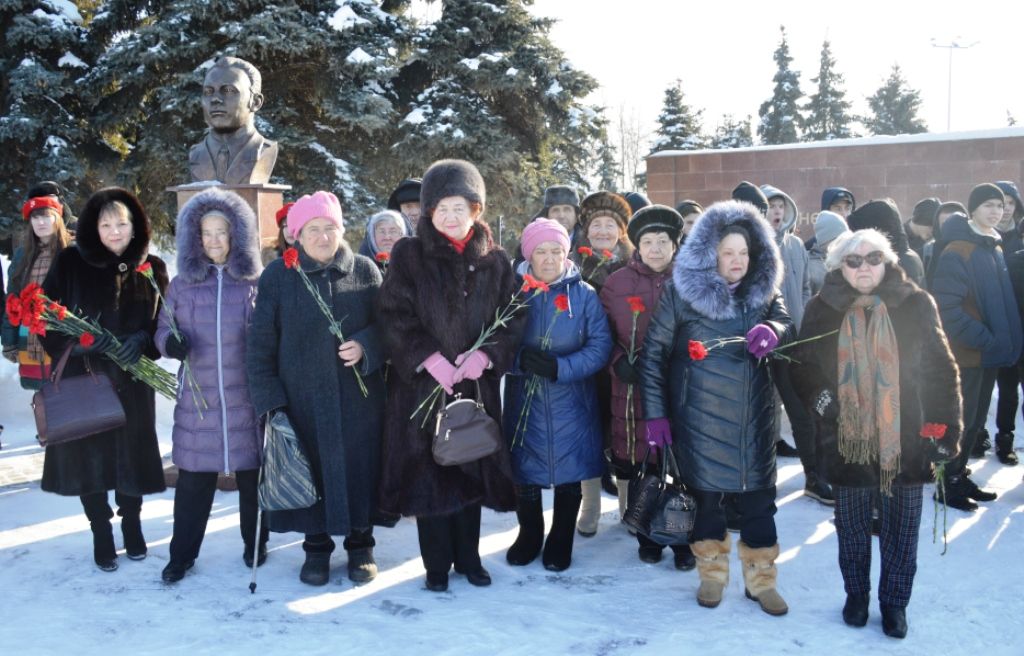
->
xmin=640 ymin=202 xmax=793 ymax=492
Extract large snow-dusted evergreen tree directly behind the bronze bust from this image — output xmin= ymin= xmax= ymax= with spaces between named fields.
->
xmin=87 ymin=0 xmax=408 ymax=235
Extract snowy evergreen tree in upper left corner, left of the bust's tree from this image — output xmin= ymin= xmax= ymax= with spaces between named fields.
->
xmin=0 ymin=0 xmax=97 ymax=245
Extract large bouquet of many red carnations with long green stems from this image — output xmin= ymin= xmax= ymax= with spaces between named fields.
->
xmin=6 ymin=282 xmax=178 ymax=401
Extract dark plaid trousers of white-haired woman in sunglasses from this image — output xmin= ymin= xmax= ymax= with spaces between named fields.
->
xmin=833 ymin=485 xmax=922 ymax=608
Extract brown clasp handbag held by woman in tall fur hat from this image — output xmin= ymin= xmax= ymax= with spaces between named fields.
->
xmin=432 ymin=382 xmax=502 ymax=467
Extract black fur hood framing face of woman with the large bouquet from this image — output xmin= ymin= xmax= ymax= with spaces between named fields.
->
xmin=75 ymin=187 xmax=151 ymax=268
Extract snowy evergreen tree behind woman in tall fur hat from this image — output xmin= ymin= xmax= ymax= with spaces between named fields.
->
xmin=390 ymin=0 xmax=600 ymax=246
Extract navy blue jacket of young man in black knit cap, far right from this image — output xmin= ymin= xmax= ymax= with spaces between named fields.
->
xmin=932 ymin=215 xmax=1024 ymax=368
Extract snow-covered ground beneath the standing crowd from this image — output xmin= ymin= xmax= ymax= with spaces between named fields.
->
xmin=0 ymin=247 xmax=1024 ymax=656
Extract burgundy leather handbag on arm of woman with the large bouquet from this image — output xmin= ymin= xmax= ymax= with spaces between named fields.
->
xmin=32 ymin=345 xmax=127 ymax=446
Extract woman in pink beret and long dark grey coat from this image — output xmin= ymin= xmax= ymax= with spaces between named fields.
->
xmin=246 ymin=191 xmax=386 ymax=585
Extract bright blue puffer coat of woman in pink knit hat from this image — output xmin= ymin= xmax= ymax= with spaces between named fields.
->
xmin=503 ymin=264 xmax=611 ymax=486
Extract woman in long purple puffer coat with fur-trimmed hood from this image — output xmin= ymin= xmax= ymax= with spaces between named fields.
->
xmin=156 ymin=187 xmax=267 ymax=583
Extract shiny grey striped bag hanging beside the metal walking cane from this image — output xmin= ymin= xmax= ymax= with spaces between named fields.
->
xmin=259 ymin=411 xmax=319 ymax=511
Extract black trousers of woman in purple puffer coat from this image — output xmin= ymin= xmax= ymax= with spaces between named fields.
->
xmin=170 ymin=469 xmax=269 ymax=563
